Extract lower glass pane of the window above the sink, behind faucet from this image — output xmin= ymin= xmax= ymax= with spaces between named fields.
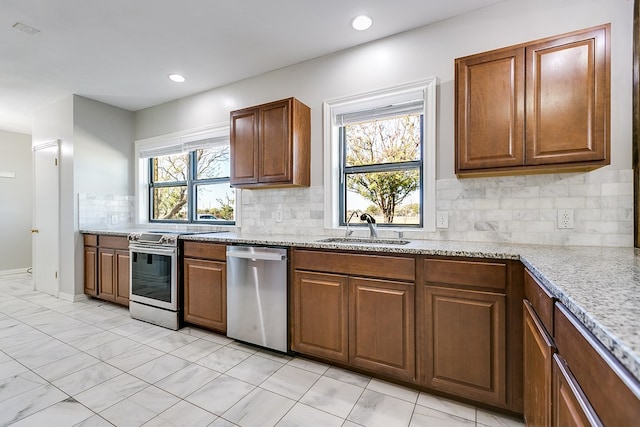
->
xmin=345 ymin=169 xmax=422 ymax=225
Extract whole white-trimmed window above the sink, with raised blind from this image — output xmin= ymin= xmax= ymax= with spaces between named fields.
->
xmin=325 ymin=79 xmax=435 ymax=231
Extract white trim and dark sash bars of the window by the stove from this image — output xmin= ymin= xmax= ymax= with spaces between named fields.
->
xmin=134 ymin=123 xmax=242 ymax=227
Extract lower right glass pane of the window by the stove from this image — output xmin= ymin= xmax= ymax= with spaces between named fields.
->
xmin=196 ymin=182 xmax=235 ymax=221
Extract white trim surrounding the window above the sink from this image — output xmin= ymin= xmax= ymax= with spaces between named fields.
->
xmin=322 ymin=77 xmax=438 ymax=231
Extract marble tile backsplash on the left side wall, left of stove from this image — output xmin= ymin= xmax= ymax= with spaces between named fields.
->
xmin=78 ymin=193 xmax=135 ymax=230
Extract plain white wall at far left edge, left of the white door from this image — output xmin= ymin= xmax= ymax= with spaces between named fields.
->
xmin=0 ymin=130 xmax=33 ymax=272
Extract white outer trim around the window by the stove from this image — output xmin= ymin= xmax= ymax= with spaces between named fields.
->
xmin=134 ymin=122 xmax=242 ymax=227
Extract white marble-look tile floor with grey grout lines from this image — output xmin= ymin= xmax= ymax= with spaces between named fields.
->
xmin=0 ymin=274 xmax=522 ymax=427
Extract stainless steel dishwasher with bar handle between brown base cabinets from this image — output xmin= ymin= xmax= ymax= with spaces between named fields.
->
xmin=227 ymin=246 xmax=288 ymax=353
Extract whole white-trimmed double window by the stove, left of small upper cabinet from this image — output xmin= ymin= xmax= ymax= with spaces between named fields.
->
xmin=136 ymin=126 xmax=237 ymax=225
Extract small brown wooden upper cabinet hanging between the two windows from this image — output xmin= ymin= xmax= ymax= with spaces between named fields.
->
xmin=231 ymin=98 xmax=311 ymax=188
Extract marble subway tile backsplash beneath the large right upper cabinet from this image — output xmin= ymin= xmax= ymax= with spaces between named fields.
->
xmin=436 ymin=169 xmax=633 ymax=247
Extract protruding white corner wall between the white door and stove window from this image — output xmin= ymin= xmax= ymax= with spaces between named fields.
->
xmin=33 ymin=95 xmax=134 ymax=299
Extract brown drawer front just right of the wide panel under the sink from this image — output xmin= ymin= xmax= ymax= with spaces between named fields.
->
xmin=424 ymin=259 xmax=507 ymax=290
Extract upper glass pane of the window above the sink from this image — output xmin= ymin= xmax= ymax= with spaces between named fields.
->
xmin=345 ymin=114 xmax=421 ymax=166
